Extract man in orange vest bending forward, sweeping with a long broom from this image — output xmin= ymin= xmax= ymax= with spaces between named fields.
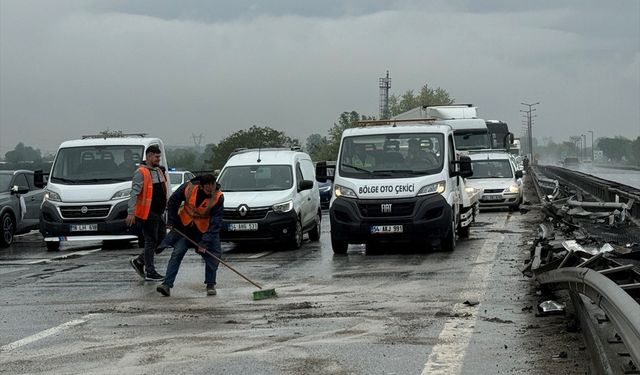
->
xmin=156 ymin=174 xmax=224 ymax=297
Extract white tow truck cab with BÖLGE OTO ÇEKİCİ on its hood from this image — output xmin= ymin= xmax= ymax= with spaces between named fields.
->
xmin=316 ymin=119 xmax=472 ymax=254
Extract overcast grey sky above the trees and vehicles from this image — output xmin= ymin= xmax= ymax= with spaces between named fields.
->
xmin=0 ymin=0 xmax=640 ymax=156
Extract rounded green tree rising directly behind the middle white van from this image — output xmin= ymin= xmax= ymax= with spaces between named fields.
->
xmin=210 ymin=125 xmax=299 ymax=169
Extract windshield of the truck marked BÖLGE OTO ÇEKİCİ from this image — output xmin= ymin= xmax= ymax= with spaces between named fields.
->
xmin=340 ymin=133 xmax=444 ymax=179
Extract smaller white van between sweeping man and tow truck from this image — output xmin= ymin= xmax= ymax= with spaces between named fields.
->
xmin=218 ymin=149 xmax=322 ymax=249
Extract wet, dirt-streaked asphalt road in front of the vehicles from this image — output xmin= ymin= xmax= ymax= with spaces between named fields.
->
xmin=0 ymin=211 xmax=589 ymax=374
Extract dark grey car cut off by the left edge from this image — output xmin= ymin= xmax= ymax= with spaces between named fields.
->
xmin=0 ymin=170 xmax=44 ymax=247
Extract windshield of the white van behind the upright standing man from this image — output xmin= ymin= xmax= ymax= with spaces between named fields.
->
xmin=49 ymin=145 xmax=144 ymax=184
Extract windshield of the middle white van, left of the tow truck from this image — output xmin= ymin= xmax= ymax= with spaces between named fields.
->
xmin=218 ymin=165 xmax=293 ymax=192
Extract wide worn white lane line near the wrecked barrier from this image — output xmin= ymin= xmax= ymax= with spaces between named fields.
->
xmin=422 ymin=216 xmax=508 ymax=375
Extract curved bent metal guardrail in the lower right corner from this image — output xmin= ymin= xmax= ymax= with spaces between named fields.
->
xmin=536 ymin=267 xmax=640 ymax=364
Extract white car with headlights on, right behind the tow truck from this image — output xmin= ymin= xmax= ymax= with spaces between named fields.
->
xmin=467 ymin=152 xmax=522 ymax=211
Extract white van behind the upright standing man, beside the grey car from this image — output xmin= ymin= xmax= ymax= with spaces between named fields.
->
xmin=40 ymin=132 xmax=167 ymax=250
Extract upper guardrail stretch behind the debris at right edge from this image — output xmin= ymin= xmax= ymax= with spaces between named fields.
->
xmin=537 ymin=165 xmax=640 ymax=220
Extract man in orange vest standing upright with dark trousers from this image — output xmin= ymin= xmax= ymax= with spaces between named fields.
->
xmin=125 ymin=145 xmax=168 ymax=281
